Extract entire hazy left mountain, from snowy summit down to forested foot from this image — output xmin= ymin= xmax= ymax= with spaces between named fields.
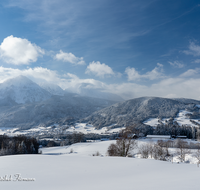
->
xmin=0 ymin=76 xmax=119 ymax=129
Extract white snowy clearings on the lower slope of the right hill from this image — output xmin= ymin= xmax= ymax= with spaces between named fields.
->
xmin=143 ymin=109 xmax=200 ymax=127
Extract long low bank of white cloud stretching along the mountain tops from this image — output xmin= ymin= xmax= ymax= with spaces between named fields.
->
xmin=0 ymin=67 xmax=200 ymax=100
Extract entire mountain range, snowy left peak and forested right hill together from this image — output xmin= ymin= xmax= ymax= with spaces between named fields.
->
xmin=0 ymin=76 xmax=200 ymax=133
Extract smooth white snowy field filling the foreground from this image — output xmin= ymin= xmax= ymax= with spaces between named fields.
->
xmin=0 ymin=140 xmax=200 ymax=190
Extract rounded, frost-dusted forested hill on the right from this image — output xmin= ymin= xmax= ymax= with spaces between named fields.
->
xmin=81 ymin=97 xmax=200 ymax=129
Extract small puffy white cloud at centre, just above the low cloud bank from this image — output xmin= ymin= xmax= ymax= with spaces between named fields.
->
xmin=85 ymin=61 xmax=115 ymax=78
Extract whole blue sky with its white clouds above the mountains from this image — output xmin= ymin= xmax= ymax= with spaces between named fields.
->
xmin=0 ymin=0 xmax=200 ymax=99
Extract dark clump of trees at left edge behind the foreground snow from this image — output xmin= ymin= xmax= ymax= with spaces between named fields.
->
xmin=0 ymin=135 xmax=39 ymax=156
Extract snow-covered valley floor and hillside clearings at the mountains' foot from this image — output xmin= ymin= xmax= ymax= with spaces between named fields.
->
xmin=0 ymin=108 xmax=200 ymax=136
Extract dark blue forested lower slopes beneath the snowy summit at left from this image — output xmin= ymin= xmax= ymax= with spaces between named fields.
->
xmin=0 ymin=94 xmax=116 ymax=129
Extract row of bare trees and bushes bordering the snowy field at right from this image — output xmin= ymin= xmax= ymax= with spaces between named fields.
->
xmin=107 ymin=128 xmax=200 ymax=164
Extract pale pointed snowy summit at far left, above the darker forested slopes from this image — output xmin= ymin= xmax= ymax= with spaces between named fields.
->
xmin=0 ymin=75 xmax=51 ymax=104
